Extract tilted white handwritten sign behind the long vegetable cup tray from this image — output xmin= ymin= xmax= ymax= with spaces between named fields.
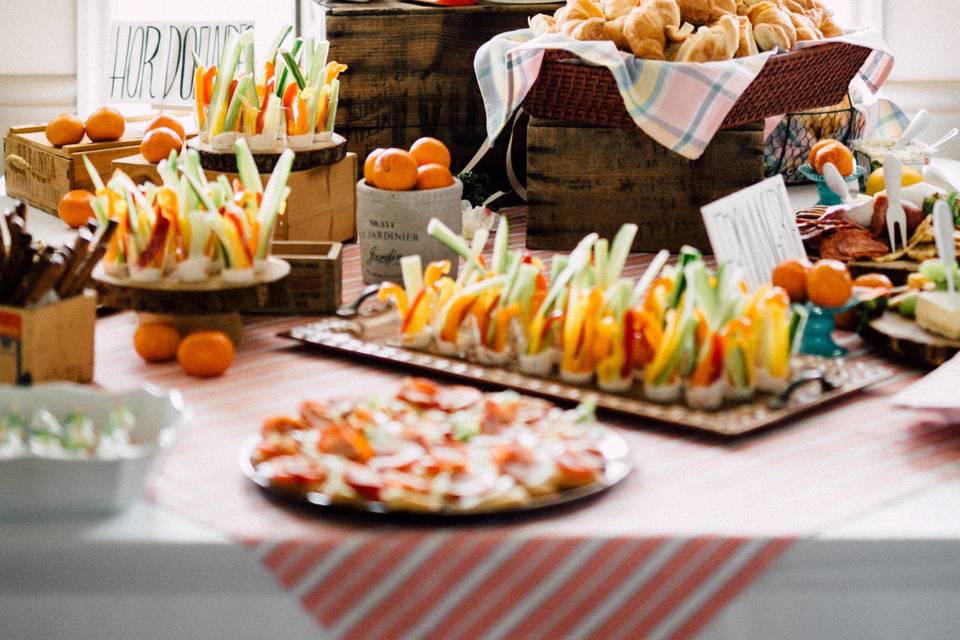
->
xmin=700 ymin=175 xmax=807 ymax=288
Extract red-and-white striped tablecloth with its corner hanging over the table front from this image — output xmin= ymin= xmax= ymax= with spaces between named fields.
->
xmin=96 ymin=211 xmax=960 ymax=638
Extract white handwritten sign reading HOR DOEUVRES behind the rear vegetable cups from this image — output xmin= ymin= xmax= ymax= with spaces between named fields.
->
xmin=103 ymin=21 xmax=253 ymax=105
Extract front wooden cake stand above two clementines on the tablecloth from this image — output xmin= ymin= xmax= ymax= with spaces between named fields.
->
xmin=93 ymin=256 xmax=290 ymax=345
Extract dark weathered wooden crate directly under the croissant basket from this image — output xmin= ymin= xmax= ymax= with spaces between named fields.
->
xmin=527 ymin=118 xmax=763 ymax=251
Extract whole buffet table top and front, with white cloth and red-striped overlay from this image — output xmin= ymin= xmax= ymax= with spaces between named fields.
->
xmin=0 ymin=176 xmax=960 ymax=640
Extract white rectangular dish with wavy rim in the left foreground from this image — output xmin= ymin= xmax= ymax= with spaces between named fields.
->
xmin=0 ymin=383 xmax=187 ymax=518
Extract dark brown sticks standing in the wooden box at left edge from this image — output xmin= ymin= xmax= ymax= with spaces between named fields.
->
xmin=0 ymin=204 xmax=117 ymax=307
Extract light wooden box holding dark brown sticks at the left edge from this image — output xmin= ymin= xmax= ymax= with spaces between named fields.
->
xmin=0 ymin=291 xmax=97 ymax=383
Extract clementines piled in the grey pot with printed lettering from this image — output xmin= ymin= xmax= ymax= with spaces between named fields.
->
xmin=363 ymin=138 xmax=453 ymax=191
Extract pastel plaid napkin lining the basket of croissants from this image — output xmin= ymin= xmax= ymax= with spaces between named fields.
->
xmin=474 ymin=29 xmax=893 ymax=159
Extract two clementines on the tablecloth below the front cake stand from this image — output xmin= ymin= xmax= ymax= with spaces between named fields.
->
xmin=133 ymin=322 xmax=235 ymax=378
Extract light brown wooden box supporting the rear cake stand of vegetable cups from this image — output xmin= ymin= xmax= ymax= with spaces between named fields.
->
xmin=113 ymin=153 xmax=357 ymax=242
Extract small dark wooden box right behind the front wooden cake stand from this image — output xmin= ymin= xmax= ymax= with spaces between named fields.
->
xmin=261 ymin=240 xmax=343 ymax=315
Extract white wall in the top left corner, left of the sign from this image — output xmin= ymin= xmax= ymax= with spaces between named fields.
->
xmin=0 ymin=0 xmax=77 ymax=154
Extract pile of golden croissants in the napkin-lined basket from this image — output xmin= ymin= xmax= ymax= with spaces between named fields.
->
xmin=530 ymin=0 xmax=843 ymax=62
